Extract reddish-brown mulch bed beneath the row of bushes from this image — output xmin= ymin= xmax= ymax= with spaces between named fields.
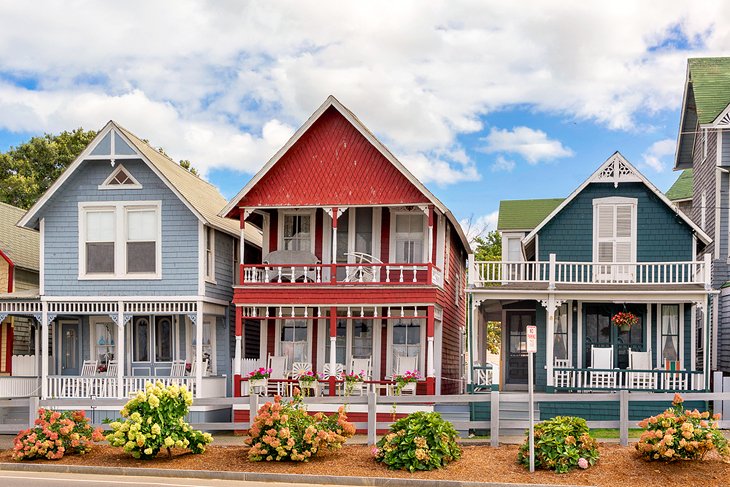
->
xmin=0 ymin=444 xmax=730 ymax=487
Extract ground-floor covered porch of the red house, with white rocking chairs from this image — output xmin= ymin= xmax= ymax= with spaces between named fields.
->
xmin=233 ymin=303 xmax=446 ymax=396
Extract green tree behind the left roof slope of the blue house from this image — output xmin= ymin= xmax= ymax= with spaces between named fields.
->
xmin=0 ymin=128 xmax=96 ymax=208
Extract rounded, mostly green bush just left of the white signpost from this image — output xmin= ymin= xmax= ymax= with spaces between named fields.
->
xmin=373 ymin=412 xmax=461 ymax=472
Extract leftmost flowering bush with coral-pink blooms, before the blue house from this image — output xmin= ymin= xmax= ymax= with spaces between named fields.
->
xmin=13 ymin=408 xmax=104 ymax=460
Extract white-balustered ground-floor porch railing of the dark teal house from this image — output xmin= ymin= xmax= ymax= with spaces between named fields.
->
xmin=553 ymin=367 xmax=705 ymax=392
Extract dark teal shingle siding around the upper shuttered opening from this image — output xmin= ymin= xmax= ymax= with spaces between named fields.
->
xmin=538 ymin=183 xmax=692 ymax=262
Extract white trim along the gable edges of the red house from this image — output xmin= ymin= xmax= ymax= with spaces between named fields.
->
xmin=218 ymin=95 xmax=471 ymax=253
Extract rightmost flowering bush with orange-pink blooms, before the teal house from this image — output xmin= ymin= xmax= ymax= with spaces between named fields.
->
xmin=636 ymin=394 xmax=730 ymax=462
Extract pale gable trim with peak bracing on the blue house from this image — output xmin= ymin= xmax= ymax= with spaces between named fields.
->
xmin=17 ymin=120 xmax=208 ymax=233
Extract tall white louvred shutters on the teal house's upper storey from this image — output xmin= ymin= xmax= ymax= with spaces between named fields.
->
xmin=593 ymin=197 xmax=637 ymax=281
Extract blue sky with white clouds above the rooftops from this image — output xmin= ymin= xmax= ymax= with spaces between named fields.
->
xmin=0 ymin=0 xmax=730 ymax=234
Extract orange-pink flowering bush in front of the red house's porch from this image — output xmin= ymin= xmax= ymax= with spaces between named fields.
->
xmin=245 ymin=388 xmax=355 ymax=462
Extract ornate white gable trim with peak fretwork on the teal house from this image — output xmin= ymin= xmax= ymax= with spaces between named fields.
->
xmin=522 ymin=152 xmax=712 ymax=245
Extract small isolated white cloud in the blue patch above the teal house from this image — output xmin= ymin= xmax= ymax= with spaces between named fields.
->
xmin=482 ymin=127 xmax=573 ymax=167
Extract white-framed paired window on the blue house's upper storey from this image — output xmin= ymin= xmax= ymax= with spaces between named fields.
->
xmin=79 ymin=202 xmax=162 ymax=279
